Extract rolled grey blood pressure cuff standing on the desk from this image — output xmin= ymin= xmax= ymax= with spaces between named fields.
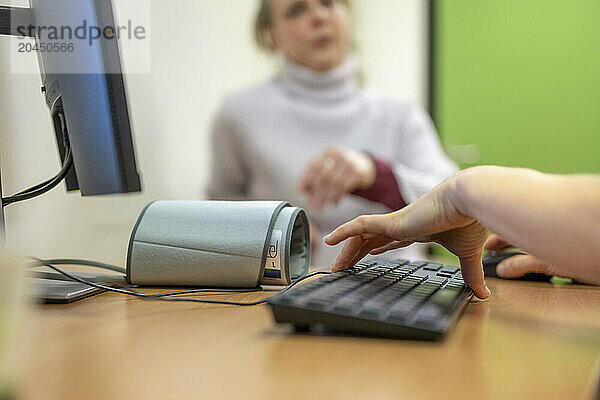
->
xmin=127 ymin=201 xmax=310 ymax=288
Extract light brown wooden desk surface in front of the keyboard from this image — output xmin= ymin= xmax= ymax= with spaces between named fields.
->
xmin=16 ymin=279 xmax=600 ymax=400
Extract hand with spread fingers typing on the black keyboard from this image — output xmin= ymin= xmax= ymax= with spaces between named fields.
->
xmin=324 ymin=175 xmax=490 ymax=299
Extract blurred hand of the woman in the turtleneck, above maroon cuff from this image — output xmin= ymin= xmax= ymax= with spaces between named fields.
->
xmin=298 ymin=149 xmax=376 ymax=210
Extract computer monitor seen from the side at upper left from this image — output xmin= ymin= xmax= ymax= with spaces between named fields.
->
xmin=29 ymin=0 xmax=141 ymax=196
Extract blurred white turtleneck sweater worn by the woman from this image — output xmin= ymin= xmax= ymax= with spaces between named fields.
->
xmin=207 ymin=59 xmax=456 ymax=266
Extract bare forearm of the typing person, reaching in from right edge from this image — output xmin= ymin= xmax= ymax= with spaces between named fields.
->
xmin=453 ymin=167 xmax=600 ymax=283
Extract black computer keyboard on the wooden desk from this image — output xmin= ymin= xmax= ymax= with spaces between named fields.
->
xmin=268 ymin=260 xmax=473 ymax=340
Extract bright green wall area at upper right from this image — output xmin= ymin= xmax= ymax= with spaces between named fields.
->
xmin=434 ymin=0 xmax=600 ymax=173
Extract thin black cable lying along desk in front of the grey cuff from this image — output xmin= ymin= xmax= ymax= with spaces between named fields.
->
xmin=36 ymin=259 xmax=330 ymax=307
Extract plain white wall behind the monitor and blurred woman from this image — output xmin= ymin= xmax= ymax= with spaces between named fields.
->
xmin=0 ymin=0 xmax=427 ymax=263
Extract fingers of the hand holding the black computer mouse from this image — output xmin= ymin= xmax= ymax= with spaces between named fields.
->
xmin=485 ymin=235 xmax=559 ymax=278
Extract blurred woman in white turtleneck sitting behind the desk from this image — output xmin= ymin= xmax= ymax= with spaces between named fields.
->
xmin=207 ymin=0 xmax=456 ymax=265
